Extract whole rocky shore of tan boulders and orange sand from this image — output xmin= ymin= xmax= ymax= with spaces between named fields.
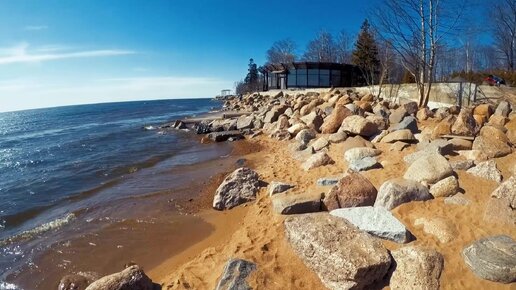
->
xmin=60 ymin=89 xmax=516 ymax=289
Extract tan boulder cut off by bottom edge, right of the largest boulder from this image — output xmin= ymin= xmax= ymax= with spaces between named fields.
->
xmin=389 ymin=246 xmax=444 ymax=290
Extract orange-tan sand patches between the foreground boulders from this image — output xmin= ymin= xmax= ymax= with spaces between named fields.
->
xmin=149 ymin=130 xmax=516 ymax=289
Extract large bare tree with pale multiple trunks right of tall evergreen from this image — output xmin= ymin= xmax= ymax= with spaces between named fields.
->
xmin=373 ymin=0 xmax=462 ymax=107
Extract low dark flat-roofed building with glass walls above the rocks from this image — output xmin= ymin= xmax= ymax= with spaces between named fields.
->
xmin=264 ymin=62 xmax=365 ymax=90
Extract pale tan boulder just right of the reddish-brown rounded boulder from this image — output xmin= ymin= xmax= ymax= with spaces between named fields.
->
xmin=374 ymin=178 xmax=432 ymax=210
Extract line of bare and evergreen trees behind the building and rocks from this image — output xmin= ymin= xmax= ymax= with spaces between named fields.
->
xmin=237 ymin=0 xmax=516 ymax=106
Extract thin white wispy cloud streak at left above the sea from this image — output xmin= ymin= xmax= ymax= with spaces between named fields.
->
xmin=0 ymin=43 xmax=136 ymax=65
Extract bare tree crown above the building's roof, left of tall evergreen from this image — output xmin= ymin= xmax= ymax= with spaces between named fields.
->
xmin=303 ymin=30 xmax=337 ymax=62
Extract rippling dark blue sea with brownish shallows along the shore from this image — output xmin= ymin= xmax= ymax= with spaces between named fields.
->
xmin=0 ymin=99 xmax=229 ymax=289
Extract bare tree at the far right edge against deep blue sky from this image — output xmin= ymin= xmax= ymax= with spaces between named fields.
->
xmin=490 ymin=0 xmax=516 ymax=72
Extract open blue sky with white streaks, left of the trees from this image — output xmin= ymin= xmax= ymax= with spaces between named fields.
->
xmin=0 ymin=0 xmax=484 ymax=111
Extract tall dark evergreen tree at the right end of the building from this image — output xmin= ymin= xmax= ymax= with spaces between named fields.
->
xmin=351 ymin=19 xmax=380 ymax=85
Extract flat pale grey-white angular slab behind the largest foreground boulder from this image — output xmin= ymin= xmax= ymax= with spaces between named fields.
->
xmin=330 ymin=206 xmax=412 ymax=243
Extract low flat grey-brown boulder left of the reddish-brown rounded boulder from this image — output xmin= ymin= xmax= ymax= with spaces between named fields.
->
xmin=272 ymin=193 xmax=321 ymax=214
